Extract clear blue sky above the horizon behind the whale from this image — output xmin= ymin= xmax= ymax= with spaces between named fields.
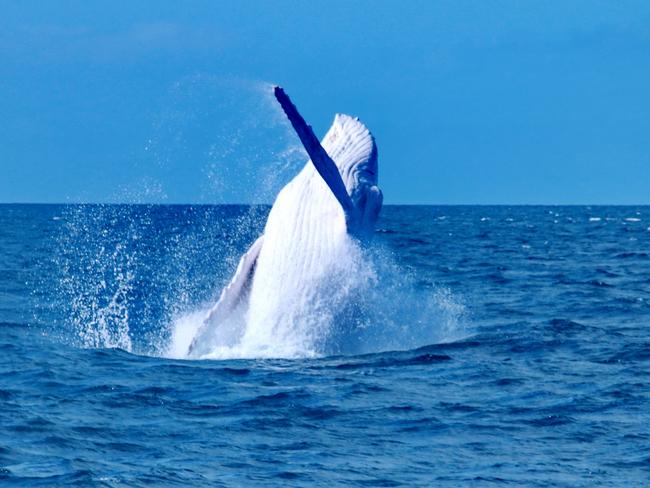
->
xmin=0 ymin=0 xmax=650 ymax=204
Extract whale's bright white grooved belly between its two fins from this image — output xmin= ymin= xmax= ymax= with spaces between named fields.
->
xmin=244 ymin=166 xmax=350 ymax=348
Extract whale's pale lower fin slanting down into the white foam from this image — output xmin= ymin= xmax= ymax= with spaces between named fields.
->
xmin=188 ymin=235 xmax=264 ymax=354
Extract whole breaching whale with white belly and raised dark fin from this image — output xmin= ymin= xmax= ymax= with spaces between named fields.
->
xmin=188 ymin=87 xmax=382 ymax=357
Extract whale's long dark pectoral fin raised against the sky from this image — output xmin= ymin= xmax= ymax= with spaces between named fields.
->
xmin=274 ymin=86 xmax=354 ymax=222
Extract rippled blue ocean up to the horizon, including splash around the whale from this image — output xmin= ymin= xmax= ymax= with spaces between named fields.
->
xmin=0 ymin=205 xmax=650 ymax=486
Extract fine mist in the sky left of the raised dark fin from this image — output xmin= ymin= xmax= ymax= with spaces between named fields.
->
xmin=109 ymin=74 xmax=306 ymax=204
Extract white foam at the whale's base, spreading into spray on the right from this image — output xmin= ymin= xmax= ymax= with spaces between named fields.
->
xmin=166 ymin=238 xmax=467 ymax=359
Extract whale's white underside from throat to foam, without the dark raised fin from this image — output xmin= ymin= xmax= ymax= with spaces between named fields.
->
xmin=185 ymin=107 xmax=378 ymax=357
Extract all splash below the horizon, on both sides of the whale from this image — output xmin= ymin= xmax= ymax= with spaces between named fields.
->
xmin=54 ymin=205 xmax=467 ymax=359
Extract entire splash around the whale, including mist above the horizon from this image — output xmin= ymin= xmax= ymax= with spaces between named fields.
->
xmin=49 ymin=76 xmax=465 ymax=359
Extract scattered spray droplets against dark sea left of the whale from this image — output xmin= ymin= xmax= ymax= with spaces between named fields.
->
xmin=48 ymin=204 xmax=261 ymax=354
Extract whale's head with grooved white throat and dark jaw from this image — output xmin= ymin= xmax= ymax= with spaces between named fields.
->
xmin=322 ymin=114 xmax=383 ymax=235
